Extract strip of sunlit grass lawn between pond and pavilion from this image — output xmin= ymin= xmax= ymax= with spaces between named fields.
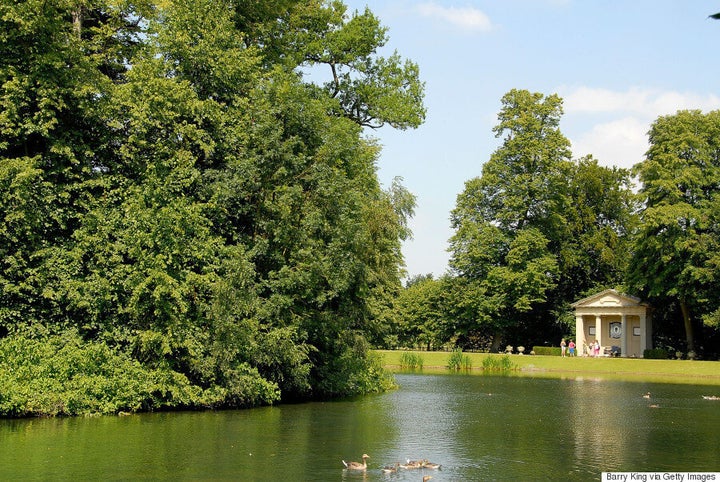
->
xmin=378 ymin=350 xmax=720 ymax=385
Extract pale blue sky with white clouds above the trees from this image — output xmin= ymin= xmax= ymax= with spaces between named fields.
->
xmin=345 ymin=0 xmax=720 ymax=277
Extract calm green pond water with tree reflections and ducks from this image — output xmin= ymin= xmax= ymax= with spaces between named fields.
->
xmin=0 ymin=374 xmax=720 ymax=482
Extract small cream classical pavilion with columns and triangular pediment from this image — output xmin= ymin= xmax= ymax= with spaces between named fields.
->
xmin=571 ymin=290 xmax=652 ymax=358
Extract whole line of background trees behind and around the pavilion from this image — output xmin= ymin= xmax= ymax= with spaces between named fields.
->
xmin=380 ymin=90 xmax=720 ymax=359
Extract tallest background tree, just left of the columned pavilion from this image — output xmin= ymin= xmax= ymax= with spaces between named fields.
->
xmin=450 ymin=90 xmax=571 ymax=349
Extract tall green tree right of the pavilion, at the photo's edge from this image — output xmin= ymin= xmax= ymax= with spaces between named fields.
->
xmin=630 ymin=111 xmax=720 ymax=350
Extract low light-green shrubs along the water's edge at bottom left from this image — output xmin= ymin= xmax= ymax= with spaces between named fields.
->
xmin=0 ymin=332 xmax=280 ymax=417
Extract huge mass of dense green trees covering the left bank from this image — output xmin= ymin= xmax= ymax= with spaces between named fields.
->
xmin=0 ymin=0 xmax=424 ymax=415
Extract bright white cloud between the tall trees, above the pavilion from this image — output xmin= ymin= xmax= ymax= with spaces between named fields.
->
xmin=558 ymin=87 xmax=720 ymax=167
